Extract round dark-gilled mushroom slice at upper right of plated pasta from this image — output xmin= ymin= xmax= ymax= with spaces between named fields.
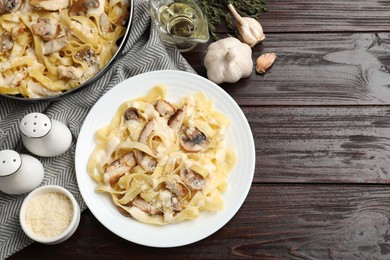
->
xmin=180 ymin=127 xmax=209 ymax=152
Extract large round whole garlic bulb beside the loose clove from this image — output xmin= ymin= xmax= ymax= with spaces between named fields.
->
xmin=204 ymin=37 xmax=253 ymax=84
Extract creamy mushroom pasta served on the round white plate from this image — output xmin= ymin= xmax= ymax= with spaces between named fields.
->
xmin=88 ymin=85 xmax=236 ymax=225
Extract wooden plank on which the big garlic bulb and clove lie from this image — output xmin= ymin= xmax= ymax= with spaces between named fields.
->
xmin=184 ymin=33 xmax=390 ymax=105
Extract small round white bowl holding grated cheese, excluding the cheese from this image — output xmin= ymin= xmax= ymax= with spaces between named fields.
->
xmin=19 ymin=185 xmax=80 ymax=245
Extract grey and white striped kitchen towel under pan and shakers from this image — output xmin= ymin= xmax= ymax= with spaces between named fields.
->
xmin=0 ymin=0 xmax=194 ymax=259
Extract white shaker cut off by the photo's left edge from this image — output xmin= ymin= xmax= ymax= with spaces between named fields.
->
xmin=0 ymin=150 xmax=44 ymax=194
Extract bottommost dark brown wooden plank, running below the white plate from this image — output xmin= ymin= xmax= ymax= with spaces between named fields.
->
xmin=9 ymin=185 xmax=390 ymax=260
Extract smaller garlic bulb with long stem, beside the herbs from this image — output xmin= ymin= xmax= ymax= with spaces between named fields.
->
xmin=228 ymin=4 xmax=265 ymax=47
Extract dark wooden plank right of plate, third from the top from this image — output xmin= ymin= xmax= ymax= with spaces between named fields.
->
xmin=239 ymin=106 xmax=390 ymax=183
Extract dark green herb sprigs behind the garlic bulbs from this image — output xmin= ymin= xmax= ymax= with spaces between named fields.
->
xmin=198 ymin=0 xmax=268 ymax=40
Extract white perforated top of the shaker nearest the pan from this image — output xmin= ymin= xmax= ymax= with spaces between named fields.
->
xmin=19 ymin=113 xmax=51 ymax=138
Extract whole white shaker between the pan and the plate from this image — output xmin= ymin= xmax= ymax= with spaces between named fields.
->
xmin=19 ymin=113 xmax=72 ymax=157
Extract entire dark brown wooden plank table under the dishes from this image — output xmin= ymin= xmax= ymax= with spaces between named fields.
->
xmin=10 ymin=0 xmax=390 ymax=259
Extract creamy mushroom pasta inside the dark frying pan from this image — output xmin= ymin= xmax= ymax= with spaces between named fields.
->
xmin=0 ymin=0 xmax=129 ymax=98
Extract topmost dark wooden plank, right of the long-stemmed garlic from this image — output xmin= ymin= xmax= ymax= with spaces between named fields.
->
xmin=213 ymin=0 xmax=390 ymax=34
